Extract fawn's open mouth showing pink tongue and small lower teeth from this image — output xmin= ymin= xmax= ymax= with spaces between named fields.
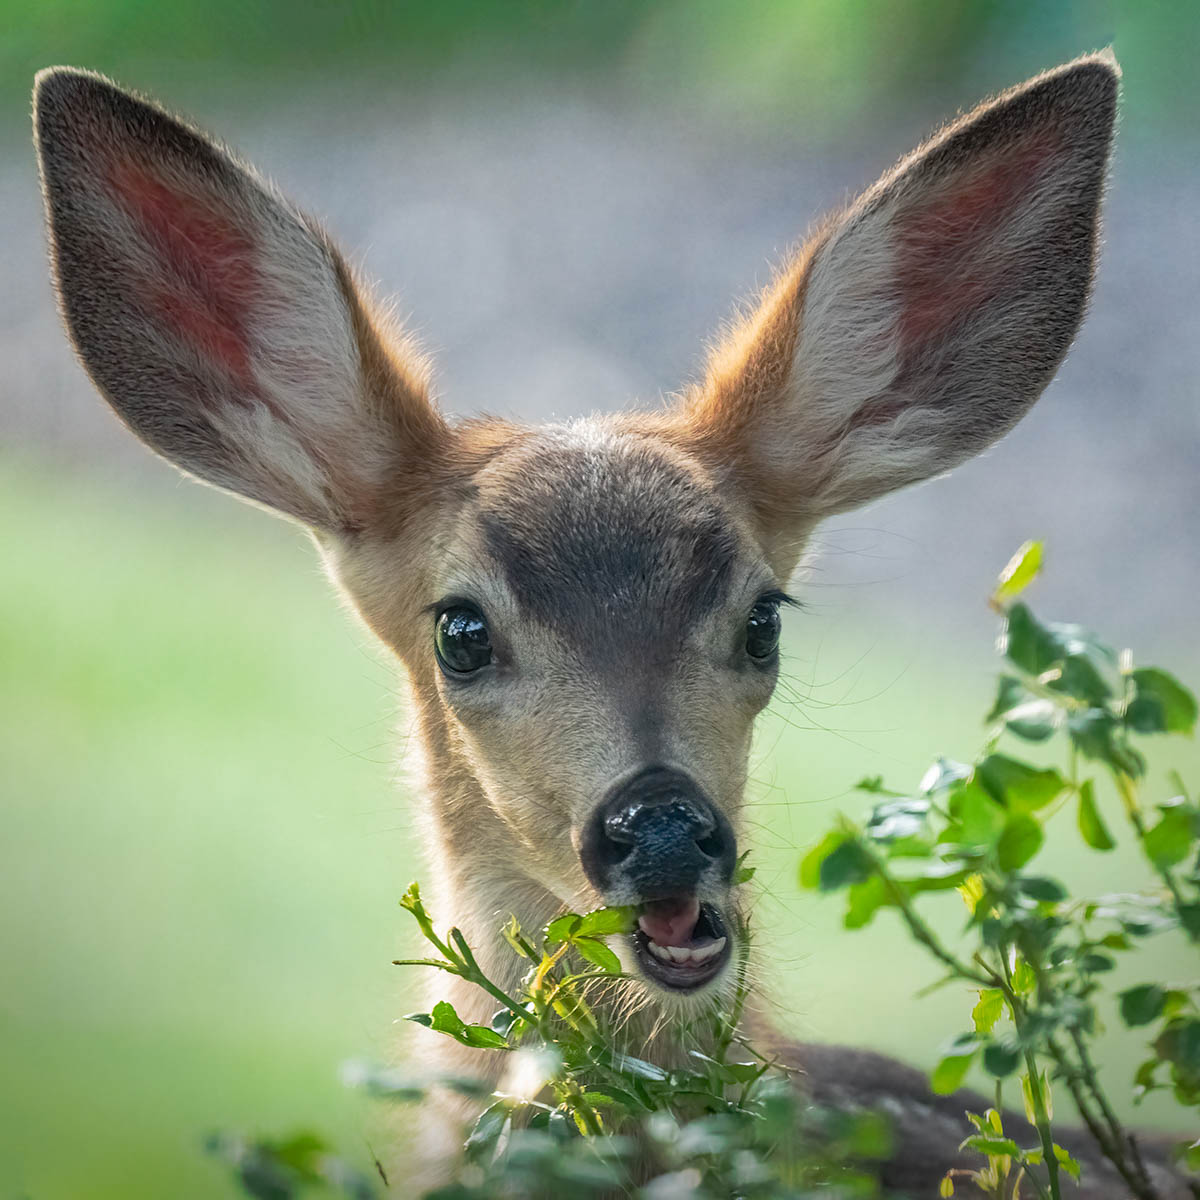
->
xmin=632 ymin=896 xmax=732 ymax=991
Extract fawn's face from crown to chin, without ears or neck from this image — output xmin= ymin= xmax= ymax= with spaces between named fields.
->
xmin=342 ymin=421 xmax=786 ymax=994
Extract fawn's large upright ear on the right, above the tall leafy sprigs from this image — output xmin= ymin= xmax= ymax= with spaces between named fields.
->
xmin=680 ymin=54 xmax=1118 ymax=566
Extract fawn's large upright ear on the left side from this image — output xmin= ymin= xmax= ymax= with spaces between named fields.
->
xmin=35 ymin=68 xmax=446 ymax=534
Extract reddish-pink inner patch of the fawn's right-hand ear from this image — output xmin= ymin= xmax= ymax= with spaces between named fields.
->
xmin=895 ymin=131 xmax=1058 ymax=348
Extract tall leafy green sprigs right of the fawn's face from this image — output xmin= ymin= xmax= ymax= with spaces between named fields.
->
xmin=800 ymin=542 xmax=1200 ymax=1200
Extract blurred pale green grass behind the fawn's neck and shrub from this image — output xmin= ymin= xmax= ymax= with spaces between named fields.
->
xmin=0 ymin=460 xmax=1200 ymax=1200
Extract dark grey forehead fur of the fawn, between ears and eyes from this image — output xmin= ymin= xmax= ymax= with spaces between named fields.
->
xmin=479 ymin=431 xmax=738 ymax=653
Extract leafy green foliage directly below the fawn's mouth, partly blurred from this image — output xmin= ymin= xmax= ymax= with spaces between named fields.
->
xmin=210 ymin=878 xmax=889 ymax=1200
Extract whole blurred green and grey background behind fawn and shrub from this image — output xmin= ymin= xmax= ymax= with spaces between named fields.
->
xmin=0 ymin=0 xmax=1200 ymax=1200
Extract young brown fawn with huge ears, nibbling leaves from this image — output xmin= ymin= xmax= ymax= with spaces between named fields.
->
xmin=35 ymin=53 xmax=1190 ymax=1196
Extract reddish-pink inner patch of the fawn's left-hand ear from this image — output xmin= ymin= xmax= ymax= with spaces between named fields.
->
xmin=108 ymin=158 xmax=260 ymax=383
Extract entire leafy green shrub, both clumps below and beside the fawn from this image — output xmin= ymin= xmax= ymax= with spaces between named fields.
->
xmin=212 ymin=544 xmax=1200 ymax=1200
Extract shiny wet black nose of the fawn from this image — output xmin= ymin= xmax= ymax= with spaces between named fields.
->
xmin=580 ymin=767 xmax=737 ymax=900
